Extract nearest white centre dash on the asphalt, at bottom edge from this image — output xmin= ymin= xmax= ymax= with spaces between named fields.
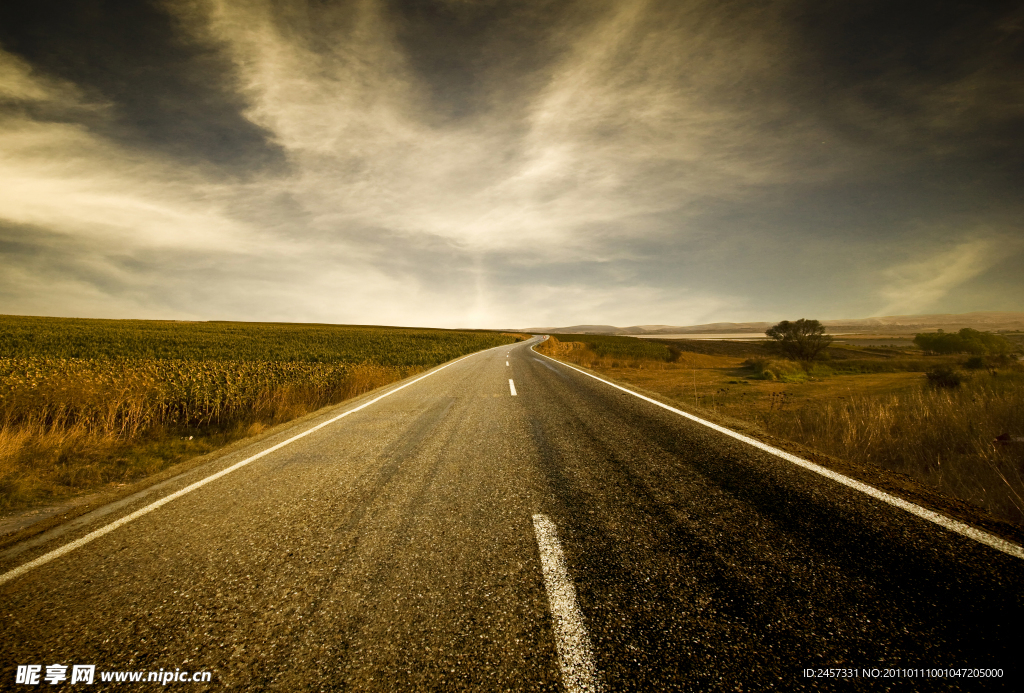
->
xmin=534 ymin=515 xmax=599 ymax=693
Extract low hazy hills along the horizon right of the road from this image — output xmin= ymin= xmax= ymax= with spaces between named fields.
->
xmin=521 ymin=311 xmax=1024 ymax=335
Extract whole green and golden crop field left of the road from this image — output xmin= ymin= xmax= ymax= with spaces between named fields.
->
xmin=0 ymin=316 xmax=522 ymax=510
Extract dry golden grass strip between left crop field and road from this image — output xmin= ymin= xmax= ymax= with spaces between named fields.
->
xmin=0 ymin=363 xmax=421 ymax=509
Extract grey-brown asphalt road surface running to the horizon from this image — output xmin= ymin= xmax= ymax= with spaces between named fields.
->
xmin=0 ymin=335 xmax=1024 ymax=691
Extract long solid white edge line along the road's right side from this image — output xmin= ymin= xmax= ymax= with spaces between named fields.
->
xmin=530 ymin=347 xmax=1024 ymax=559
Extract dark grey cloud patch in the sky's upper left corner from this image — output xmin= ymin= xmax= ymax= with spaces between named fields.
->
xmin=0 ymin=0 xmax=284 ymax=171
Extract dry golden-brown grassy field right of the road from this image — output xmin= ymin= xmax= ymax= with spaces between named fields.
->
xmin=539 ymin=335 xmax=1024 ymax=525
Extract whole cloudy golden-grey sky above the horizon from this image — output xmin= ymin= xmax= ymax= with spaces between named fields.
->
xmin=0 ymin=0 xmax=1024 ymax=329
